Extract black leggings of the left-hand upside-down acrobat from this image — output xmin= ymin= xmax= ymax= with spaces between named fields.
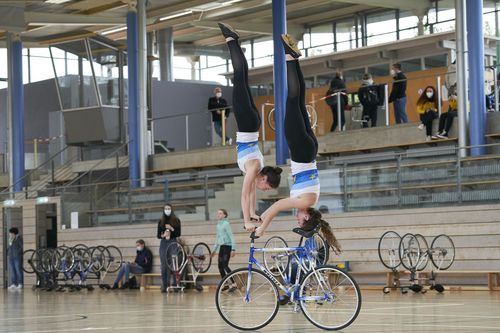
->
xmin=227 ymin=40 xmax=260 ymax=132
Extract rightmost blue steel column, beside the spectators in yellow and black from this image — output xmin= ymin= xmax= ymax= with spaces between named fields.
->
xmin=466 ymin=0 xmax=486 ymax=156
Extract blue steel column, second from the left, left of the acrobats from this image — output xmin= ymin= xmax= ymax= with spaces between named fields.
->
xmin=127 ymin=8 xmax=140 ymax=188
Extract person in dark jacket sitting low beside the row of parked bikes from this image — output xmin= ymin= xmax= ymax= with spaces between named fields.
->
xmin=112 ymin=239 xmax=153 ymax=289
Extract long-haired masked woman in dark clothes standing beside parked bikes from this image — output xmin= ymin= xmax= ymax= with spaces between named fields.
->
xmin=156 ymin=204 xmax=181 ymax=293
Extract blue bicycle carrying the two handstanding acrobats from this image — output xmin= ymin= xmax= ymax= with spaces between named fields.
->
xmin=215 ymin=228 xmax=361 ymax=330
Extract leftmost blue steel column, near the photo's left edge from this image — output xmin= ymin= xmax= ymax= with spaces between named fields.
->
xmin=10 ymin=36 xmax=24 ymax=192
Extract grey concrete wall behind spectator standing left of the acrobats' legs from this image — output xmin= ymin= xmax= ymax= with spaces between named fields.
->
xmin=152 ymin=81 xmax=236 ymax=150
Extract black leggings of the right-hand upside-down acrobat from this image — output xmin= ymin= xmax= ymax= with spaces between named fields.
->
xmin=285 ymin=60 xmax=318 ymax=163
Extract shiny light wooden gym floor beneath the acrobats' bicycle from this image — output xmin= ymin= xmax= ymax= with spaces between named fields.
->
xmin=0 ymin=289 xmax=500 ymax=333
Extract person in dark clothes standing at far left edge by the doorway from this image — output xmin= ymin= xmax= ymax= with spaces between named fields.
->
xmin=7 ymin=228 xmax=24 ymax=290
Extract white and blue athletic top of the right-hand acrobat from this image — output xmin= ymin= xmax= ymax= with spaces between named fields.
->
xmin=290 ymin=161 xmax=320 ymax=205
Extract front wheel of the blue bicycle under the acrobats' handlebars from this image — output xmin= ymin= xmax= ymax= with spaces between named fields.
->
xmin=215 ymin=268 xmax=278 ymax=331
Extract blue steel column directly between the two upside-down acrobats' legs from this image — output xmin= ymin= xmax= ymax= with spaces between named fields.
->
xmin=270 ymin=0 xmax=288 ymax=165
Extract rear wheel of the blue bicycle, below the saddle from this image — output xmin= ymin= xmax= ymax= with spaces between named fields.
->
xmin=298 ymin=266 xmax=361 ymax=331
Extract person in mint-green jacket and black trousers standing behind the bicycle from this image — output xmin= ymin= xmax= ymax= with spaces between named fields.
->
xmin=212 ymin=208 xmax=236 ymax=291
